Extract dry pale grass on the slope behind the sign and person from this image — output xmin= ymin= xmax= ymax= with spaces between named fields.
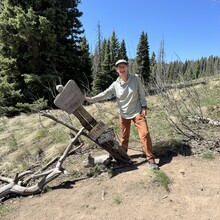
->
xmin=0 ymin=77 xmax=220 ymax=175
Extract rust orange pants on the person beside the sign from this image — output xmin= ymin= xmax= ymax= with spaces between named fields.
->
xmin=119 ymin=114 xmax=155 ymax=160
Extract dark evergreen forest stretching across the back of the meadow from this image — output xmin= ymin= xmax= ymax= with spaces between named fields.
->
xmin=0 ymin=0 xmax=220 ymax=117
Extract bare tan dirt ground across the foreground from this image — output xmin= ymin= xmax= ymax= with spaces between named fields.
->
xmin=4 ymin=150 xmax=220 ymax=220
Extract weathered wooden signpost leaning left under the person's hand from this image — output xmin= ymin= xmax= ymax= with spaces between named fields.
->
xmin=54 ymin=80 xmax=130 ymax=163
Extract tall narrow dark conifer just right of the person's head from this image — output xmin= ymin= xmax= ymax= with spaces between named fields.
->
xmin=136 ymin=32 xmax=150 ymax=83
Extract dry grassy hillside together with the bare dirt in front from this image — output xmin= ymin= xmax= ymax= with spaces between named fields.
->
xmin=0 ymin=77 xmax=220 ymax=220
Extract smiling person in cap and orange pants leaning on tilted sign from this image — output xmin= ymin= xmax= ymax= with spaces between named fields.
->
xmin=85 ymin=59 xmax=158 ymax=169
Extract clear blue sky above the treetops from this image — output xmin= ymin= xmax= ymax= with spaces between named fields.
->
xmin=78 ymin=0 xmax=220 ymax=62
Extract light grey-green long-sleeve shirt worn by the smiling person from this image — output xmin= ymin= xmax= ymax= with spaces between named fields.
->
xmin=92 ymin=74 xmax=147 ymax=119
